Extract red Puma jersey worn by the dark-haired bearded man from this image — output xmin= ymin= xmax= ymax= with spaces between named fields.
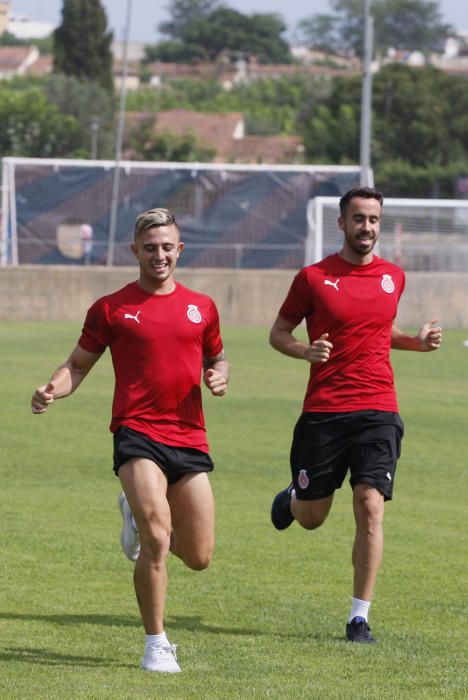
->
xmin=279 ymin=254 xmax=405 ymax=412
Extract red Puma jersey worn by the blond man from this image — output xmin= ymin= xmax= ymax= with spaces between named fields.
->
xmin=78 ymin=282 xmax=223 ymax=452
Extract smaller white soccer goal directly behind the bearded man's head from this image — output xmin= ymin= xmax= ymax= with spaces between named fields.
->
xmin=306 ymin=197 xmax=468 ymax=272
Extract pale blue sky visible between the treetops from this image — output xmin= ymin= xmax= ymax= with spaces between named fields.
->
xmin=10 ymin=0 xmax=468 ymax=43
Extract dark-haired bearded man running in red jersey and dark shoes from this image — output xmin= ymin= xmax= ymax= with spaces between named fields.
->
xmin=270 ymin=187 xmax=442 ymax=643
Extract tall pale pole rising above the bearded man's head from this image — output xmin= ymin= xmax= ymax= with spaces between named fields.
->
xmin=360 ymin=0 xmax=374 ymax=186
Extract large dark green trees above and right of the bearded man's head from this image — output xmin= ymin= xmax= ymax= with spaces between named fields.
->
xmin=302 ymin=63 xmax=468 ymax=197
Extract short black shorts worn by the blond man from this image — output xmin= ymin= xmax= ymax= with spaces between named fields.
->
xmin=114 ymin=425 xmax=214 ymax=484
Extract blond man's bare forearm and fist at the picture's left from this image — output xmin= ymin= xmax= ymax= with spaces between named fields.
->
xmin=31 ymin=345 xmax=101 ymax=413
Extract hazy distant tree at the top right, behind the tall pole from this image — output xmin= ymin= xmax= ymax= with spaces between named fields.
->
xmin=298 ymin=0 xmax=452 ymax=56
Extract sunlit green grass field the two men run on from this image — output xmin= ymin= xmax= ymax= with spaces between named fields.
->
xmin=0 ymin=322 xmax=468 ymax=700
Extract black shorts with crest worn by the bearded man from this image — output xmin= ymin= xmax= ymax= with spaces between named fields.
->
xmin=291 ymin=410 xmax=404 ymax=501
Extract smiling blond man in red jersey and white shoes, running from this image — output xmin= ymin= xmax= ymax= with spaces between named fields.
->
xmin=31 ymin=209 xmax=229 ymax=673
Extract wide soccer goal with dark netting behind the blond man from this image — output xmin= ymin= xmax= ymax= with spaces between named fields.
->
xmin=0 ymin=158 xmax=360 ymax=269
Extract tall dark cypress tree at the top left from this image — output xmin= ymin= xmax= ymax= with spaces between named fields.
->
xmin=54 ymin=0 xmax=113 ymax=91
